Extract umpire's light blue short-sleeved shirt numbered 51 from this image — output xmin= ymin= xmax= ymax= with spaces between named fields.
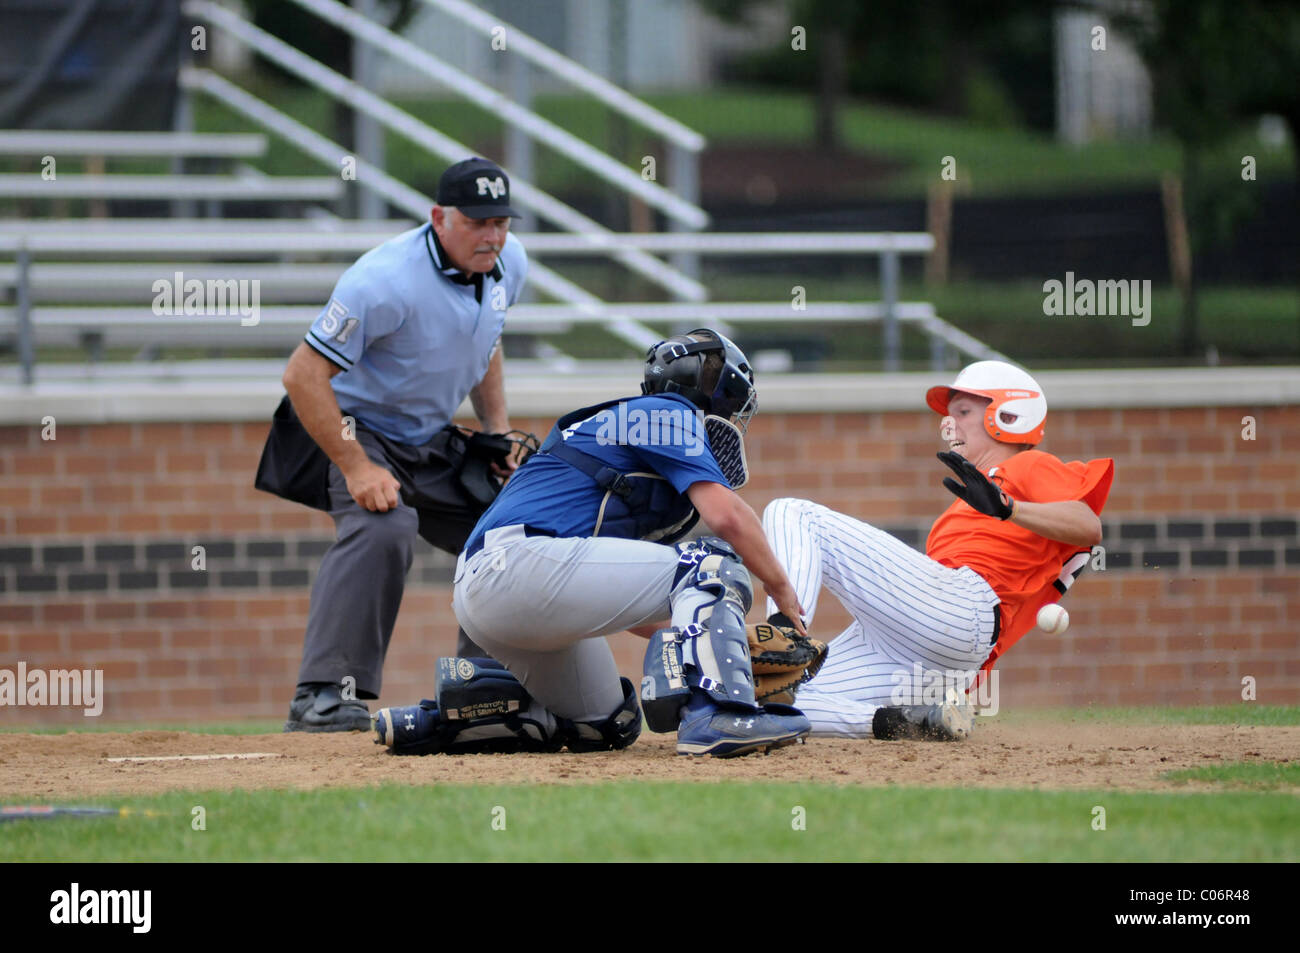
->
xmin=307 ymin=224 xmax=528 ymax=446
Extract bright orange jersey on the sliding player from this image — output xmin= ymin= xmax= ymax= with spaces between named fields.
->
xmin=926 ymin=450 xmax=1115 ymax=668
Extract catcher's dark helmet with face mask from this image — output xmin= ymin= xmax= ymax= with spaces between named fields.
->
xmin=641 ymin=328 xmax=758 ymax=433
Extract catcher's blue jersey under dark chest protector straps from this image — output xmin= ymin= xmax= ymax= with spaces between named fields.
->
xmin=465 ymin=394 xmax=729 ymax=553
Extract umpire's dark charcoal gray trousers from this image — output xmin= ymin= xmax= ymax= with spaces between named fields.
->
xmin=298 ymin=429 xmax=486 ymax=696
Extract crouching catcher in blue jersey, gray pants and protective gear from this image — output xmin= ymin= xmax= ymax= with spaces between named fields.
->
xmin=376 ymin=330 xmax=819 ymax=757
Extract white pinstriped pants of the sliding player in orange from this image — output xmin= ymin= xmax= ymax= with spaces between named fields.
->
xmin=763 ymin=498 xmax=998 ymax=738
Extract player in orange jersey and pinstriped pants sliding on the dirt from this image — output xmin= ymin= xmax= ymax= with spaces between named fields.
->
xmin=763 ymin=361 xmax=1114 ymax=741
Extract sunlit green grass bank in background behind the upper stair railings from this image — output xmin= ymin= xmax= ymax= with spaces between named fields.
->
xmin=178 ymin=82 xmax=1294 ymax=195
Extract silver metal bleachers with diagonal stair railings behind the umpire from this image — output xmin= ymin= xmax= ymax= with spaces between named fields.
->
xmin=0 ymin=0 xmax=1000 ymax=385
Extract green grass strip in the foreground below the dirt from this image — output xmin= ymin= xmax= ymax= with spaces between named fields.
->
xmin=0 ymin=783 xmax=1300 ymax=862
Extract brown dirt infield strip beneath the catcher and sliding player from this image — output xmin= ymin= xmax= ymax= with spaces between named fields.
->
xmin=0 ymin=722 xmax=1300 ymax=798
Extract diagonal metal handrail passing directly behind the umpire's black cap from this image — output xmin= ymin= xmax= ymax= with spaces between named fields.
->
xmin=182 ymin=0 xmax=709 ymax=299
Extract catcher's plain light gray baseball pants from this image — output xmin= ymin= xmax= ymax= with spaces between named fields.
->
xmin=452 ymin=527 xmax=677 ymax=722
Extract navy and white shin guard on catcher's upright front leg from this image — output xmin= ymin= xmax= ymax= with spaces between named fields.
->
xmin=641 ymin=537 xmax=757 ymax=732
